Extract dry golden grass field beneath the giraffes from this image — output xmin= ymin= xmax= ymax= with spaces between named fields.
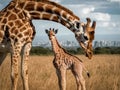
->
xmin=0 ymin=55 xmax=120 ymax=90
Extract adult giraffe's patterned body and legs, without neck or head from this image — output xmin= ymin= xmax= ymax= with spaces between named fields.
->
xmin=0 ymin=2 xmax=35 ymax=90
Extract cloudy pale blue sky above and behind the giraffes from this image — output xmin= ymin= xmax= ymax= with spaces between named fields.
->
xmin=0 ymin=0 xmax=120 ymax=41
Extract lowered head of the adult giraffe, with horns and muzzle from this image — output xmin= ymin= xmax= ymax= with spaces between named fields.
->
xmin=74 ymin=18 xmax=96 ymax=59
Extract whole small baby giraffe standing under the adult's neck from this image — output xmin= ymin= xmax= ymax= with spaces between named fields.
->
xmin=46 ymin=29 xmax=89 ymax=90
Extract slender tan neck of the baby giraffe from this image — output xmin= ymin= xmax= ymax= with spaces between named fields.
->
xmin=51 ymin=36 xmax=64 ymax=54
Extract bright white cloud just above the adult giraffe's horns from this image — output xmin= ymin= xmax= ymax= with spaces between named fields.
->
xmin=66 ymin=4 xmax=111 ymax=21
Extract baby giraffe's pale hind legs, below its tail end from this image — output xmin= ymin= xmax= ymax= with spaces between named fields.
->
xmin=72 ymin=65 xmax=86 ymax=90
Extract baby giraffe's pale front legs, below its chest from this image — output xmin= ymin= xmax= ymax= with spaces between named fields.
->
xmin=56 ymin=68 xmax=66 ymax=90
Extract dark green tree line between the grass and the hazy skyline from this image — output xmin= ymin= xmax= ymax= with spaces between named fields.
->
xmin=30 ymin=46 xmax=120 ymax=55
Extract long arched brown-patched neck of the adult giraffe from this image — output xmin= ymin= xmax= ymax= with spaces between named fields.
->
xmin=18 ymin=0 xmax=79 ymax=29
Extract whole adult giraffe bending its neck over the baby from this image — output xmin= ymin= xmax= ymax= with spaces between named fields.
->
xmin=0 ymin=0 xmax=96 ymax=90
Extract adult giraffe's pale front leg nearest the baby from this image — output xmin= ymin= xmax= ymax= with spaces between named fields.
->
xmin=21 ymin=43 xmax=31 ymax=90
